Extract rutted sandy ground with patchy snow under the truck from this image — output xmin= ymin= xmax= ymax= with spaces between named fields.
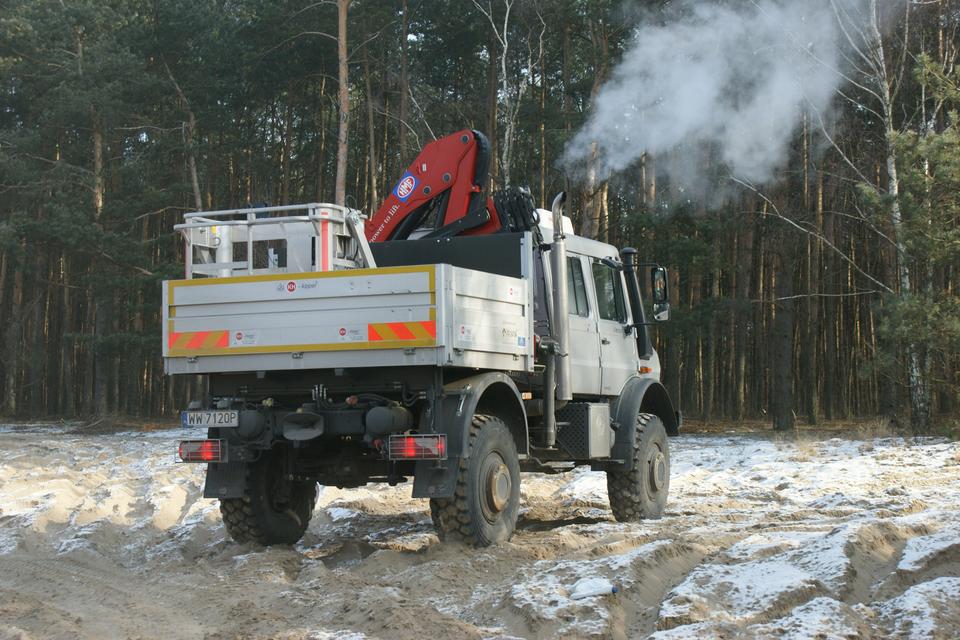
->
xmin=0 ymin=426 xmax=960 ymax=640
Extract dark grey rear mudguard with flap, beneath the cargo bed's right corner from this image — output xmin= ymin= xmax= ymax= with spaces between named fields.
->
xmin=413 ymin=372 xmax=530 ymax=498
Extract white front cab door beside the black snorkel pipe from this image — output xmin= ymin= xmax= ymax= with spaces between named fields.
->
xmin=591 ymin=261 xmax=638 ymax=396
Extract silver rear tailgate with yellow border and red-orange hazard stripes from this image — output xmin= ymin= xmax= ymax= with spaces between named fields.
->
xmin=163 ymin=265 xmax=438 ymax=373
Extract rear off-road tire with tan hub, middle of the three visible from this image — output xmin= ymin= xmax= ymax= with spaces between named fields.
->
xmin=430 ymin=414 xmax=520 ymax=547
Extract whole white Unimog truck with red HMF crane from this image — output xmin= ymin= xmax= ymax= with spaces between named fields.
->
xmin=169 ymin=130 xmax=680 ymax=546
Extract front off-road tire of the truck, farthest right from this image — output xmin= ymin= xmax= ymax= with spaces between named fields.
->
xmin=607 ymin=413 xmax=670 ymax=522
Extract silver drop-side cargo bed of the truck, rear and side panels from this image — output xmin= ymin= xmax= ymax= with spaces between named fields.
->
xmin=163 ymin=264 xmax=533 ymax=373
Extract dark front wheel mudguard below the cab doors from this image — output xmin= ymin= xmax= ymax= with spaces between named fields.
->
xmin=591 ymin=376 xmax=680 ymax=471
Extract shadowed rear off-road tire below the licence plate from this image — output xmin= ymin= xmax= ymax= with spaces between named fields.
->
xmin=220 ymin=451 xmax=317 ymax=545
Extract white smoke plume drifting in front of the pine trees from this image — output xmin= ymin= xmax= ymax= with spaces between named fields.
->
xmin=563 ymin=0 xmax=845 ymax=187
